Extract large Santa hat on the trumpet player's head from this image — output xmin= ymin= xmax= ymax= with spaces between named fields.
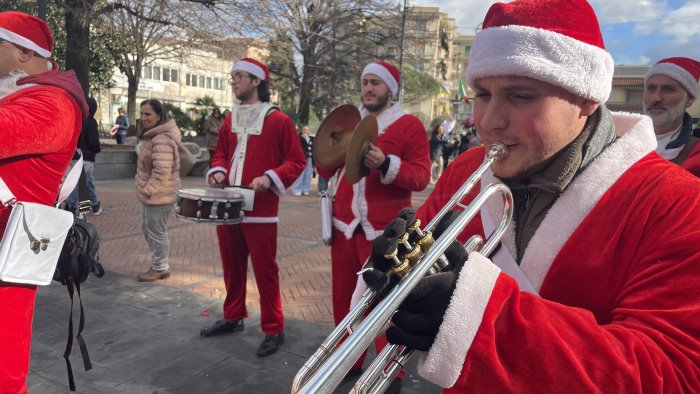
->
xmin=467 ymin=0 xmax=614 ymax=103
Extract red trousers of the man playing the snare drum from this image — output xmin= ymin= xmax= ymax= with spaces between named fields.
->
xmin=216 ymin=223 xmax=284 ymax=334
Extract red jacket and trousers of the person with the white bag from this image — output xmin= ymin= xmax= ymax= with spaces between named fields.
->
xmin=0 ymin=70 xmax=88 ymax=394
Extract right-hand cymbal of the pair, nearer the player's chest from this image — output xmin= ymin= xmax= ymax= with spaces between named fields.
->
xmin=345 ymin=115 xmax=379 ymax=184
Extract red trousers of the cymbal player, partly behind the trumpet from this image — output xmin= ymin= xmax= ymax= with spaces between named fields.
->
xmin=331 ymin=227 xmax=404 ymax=378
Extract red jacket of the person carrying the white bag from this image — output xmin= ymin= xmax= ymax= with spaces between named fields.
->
xmin=0 ymin=70 xmax=88 ymax=232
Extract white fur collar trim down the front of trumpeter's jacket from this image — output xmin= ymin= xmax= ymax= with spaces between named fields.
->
xmin=481 ymin=113 xmax=656 ymax=291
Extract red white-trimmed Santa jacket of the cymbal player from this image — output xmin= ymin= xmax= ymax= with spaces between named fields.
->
xmin=318 ymin=104 xmax=430 ymax=240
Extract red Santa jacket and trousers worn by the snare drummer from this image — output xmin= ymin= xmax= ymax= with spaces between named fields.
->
xmin=207 ymin=102 xmax=306 ymax=334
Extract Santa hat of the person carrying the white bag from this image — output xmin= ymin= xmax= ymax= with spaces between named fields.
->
xmin=0 ymin=11 xmax=53 ymax=58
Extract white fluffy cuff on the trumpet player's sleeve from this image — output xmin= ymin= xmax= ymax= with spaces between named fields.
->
xmin=418 ymin=252 xmax=501 ymax=388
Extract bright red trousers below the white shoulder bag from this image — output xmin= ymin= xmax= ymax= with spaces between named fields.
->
xmin=0 ymin=282 xmax=36 ymax=394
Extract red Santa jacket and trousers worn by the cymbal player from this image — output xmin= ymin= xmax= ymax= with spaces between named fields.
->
xmin=318 ymin=104 xmax=430 ymax=366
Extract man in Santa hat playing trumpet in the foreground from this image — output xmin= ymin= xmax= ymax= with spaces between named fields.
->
xmin=358 ymin=0 xmax=700 ymax=393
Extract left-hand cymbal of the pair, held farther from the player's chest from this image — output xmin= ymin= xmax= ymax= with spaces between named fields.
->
xmin=311 ymin=104 xmax=361 ymax=170
